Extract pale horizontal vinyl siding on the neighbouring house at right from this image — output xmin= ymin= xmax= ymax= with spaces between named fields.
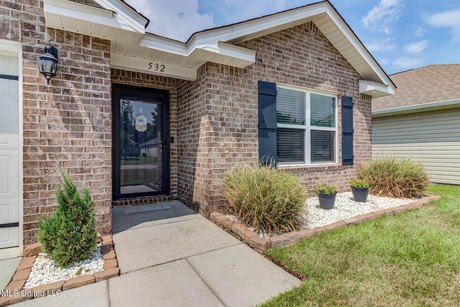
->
xmin=372 ymin=109 xmax=460 ymax=184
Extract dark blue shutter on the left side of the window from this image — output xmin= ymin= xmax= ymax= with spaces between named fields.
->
xmin=258 ymin=81 xmax=277 ymax=165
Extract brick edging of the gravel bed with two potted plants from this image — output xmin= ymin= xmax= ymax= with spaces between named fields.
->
xmin=209 ymin=195 xmax=441 ymax=253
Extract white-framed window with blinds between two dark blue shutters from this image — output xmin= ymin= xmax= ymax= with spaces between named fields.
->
xmin=276 ymin=87 xmax=337 ymax=164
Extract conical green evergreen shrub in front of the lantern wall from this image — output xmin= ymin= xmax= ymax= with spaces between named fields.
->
xmin=38 ymin=171 xmax=97 ymax=267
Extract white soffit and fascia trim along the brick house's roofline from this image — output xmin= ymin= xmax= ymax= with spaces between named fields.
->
xmin=45 ymin=0 xmax=395 ymax=88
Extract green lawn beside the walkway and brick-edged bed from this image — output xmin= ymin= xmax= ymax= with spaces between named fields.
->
xmin=266 ymin=185 xmax=460 ymax=306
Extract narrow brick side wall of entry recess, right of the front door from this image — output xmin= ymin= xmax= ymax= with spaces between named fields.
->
xmin=177 ymin=64 xmax=214 ymax=212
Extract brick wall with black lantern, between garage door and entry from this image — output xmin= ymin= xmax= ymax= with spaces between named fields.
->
xmin=0 ymin=0 xmax=112 ymax=244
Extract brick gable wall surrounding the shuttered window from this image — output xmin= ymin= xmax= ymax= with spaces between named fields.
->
xmin=194 ymin=23 xmax=371 ymax=213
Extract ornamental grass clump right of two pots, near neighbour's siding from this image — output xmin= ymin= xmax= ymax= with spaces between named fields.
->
xmin=358 ymin=158 xmax=429 ymax=198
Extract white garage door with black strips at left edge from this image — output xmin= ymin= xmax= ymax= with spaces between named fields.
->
xmin=0 ymin=52 xmax=20 ymax=249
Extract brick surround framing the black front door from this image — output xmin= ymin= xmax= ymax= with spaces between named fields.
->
xmin=111 ymin=69 xmax=179 ymax=206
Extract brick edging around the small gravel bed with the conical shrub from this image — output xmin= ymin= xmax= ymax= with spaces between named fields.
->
xmin=0 ymin=235 xmax=120 ymax=306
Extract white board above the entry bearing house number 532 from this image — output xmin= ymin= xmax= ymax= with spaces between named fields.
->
xmin=110 ymin=53 xmax=196 ymax=80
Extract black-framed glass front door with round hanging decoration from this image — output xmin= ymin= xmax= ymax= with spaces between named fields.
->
xmin=113 ymin=85 xmax=169 ymax=199
